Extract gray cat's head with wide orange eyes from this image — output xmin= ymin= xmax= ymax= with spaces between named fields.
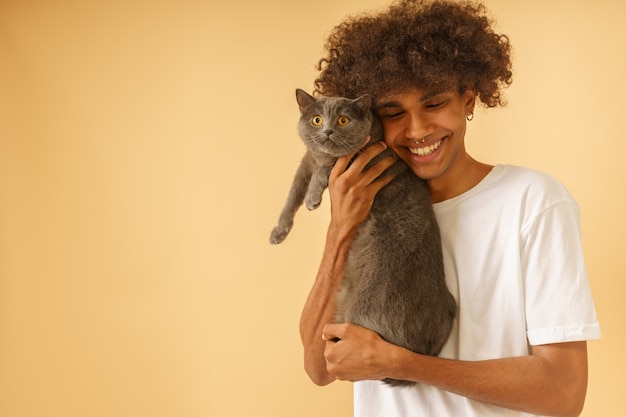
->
xmin=296 ymin=89 xmax=373 ymax=157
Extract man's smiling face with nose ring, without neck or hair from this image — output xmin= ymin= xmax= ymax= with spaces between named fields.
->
xmin=376 ymin=89 xmax=475 ymax=181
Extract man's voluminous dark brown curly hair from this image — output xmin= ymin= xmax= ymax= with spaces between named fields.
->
xmin=315 ymin=0 xmax=513 ymax=107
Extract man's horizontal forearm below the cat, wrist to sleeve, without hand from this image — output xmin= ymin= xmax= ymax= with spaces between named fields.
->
xmin=390 ymin=342 xmax=587 ymax=416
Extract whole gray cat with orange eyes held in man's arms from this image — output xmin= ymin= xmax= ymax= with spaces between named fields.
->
xmin=270 ymin=89 xmax=456 ymax=386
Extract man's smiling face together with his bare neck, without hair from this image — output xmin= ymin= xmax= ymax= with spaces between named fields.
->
xmin=370 ymin=89 xmax=491 ymax=202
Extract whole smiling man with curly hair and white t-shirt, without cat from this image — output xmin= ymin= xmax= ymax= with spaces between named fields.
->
xmin=300 ymin=1 xmax=600 ymax=417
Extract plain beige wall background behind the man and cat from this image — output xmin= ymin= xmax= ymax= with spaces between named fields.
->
xmin=0 ymin=0 xmax=626 ymax=417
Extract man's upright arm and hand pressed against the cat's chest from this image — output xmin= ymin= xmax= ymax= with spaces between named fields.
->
xmin=300 ymin=142 xmax=395 ymax=385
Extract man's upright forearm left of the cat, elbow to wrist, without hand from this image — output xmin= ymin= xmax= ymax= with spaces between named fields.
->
xmin=300 ymin=225 xmax=351 ymax=385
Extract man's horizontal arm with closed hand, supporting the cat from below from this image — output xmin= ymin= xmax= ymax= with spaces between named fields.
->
xmin=324 ymin=324 xmax=587 ymax=416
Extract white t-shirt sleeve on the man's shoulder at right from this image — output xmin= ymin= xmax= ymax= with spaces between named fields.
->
xmin=521 ymin=199 xmax=600 ymax=345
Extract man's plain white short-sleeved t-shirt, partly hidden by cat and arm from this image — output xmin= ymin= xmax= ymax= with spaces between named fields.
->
xmin=354 ymin=165 xmax=600 ymax=417
